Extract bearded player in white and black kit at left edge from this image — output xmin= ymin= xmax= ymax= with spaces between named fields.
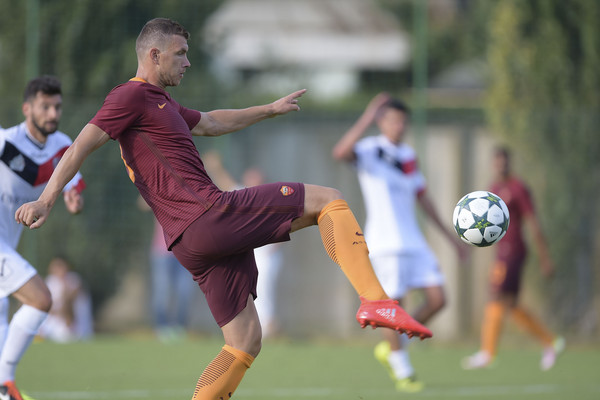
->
xmin=0 ymin=76 xmax=85 ymax=400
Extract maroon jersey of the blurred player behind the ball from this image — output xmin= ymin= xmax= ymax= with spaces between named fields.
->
xmin=490 ymin=177 xmax=533 ymax=260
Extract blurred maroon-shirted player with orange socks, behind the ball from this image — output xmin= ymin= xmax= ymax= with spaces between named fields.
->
xmin=462 ymin=147 xmax=564 ymax=371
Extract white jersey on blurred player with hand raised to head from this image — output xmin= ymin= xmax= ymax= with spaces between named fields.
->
xmin=354 ymin=135 xmax=429 ymax=255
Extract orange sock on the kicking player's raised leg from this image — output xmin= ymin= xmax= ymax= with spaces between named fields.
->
xmin=317 ymin=200 xmax=389 ymax=300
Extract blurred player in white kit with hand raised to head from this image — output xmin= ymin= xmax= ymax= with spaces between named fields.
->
xmin=333 ymin=93 xmax=467 ymax=392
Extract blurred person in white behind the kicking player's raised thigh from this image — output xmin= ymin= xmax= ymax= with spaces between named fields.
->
xmin=202 ymin=151 xmax=283 ymax=338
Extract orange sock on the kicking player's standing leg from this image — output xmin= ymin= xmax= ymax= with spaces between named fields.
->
xmin=192 ymin=345 xmax=254 ymax=400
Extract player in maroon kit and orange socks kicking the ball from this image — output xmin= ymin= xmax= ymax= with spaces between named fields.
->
xmin=15 ymin=18 xmax=431 ymax=399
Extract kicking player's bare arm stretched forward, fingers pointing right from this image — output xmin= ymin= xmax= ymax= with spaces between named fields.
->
xmin=192 ymin=89 xmax=306 ymax=136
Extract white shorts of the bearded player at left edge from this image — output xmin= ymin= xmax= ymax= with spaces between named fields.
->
xmin=0 ymin=240 xmax=37 ymax=297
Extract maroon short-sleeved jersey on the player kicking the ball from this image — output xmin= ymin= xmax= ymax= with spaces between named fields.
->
xmin=90 ymin=78 xmax=221 ymax=247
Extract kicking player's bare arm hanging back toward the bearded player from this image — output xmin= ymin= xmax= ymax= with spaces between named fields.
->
xmin=15 ymin=124 xmax=110 ymax=229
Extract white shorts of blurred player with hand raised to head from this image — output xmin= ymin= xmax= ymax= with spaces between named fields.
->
xmin=371 ymin=249 xmax=444 ymax=299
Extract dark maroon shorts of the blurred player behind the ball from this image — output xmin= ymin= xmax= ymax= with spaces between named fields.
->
xmin=490 ymin=251 xmax=526 ymax=295
